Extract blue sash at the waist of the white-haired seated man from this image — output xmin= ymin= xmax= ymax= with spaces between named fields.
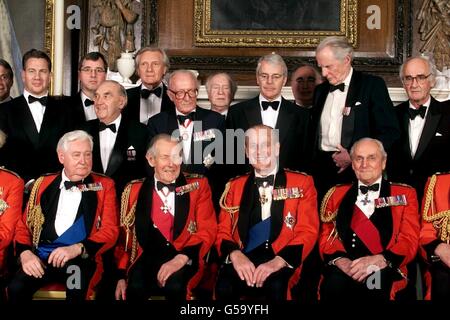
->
xmin=37 ymin=216 xmax=86 ymax=260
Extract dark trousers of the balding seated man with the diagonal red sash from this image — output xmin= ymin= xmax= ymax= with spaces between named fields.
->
xmin=320 ymin=266 xmax=395 ymax=302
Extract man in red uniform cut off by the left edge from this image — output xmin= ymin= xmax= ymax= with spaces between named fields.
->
xmin=0 ymin=131 xmax=23 ymax=302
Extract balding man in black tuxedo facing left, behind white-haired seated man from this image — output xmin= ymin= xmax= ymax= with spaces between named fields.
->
xmin=82 ymin=80 xmax=148 ymax=199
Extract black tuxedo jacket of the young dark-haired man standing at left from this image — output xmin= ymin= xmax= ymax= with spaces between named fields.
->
xmin=0 ymin=95 xmax=75 ymax=181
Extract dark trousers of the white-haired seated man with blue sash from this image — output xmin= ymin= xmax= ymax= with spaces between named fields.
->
xmin=8 ymin=257 xmax=96 ymax=303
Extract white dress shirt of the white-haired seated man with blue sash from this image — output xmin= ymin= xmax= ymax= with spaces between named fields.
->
xmin=55 ymin=170 xmax=81 ymax=236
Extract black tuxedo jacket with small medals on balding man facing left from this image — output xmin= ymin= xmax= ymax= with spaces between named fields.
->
xmin=82 ymin=117 xmax=149 ymax=198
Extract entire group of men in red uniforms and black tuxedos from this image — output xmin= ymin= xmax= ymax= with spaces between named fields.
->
xmin=0 ymin=37 xmax=450 ymax=301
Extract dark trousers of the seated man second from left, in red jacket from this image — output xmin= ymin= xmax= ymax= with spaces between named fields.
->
xmin=126 ymin=253 xmax=198 ymax=301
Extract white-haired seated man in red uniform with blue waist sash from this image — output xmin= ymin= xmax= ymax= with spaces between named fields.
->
xmin=8 ymin=130 xmax=119 ymax=302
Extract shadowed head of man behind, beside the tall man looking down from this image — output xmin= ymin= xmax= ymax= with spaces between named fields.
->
xmin=291 ymin=64 xmax=323 ymax=109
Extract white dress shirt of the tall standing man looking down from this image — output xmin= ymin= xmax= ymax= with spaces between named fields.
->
xmin=320 ymin=68 xmax=353 ymax=151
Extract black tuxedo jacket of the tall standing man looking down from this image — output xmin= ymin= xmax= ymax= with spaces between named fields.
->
xmin=311 ymin=70 xmax=400 ymax=151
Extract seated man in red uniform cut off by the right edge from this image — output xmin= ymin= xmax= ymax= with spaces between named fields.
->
xmin=420 ymin=173 xmax=450 ymax=302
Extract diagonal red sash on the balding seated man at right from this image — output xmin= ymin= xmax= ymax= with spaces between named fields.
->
xmin=350 ymin=205 xmax=383 ymax=254
